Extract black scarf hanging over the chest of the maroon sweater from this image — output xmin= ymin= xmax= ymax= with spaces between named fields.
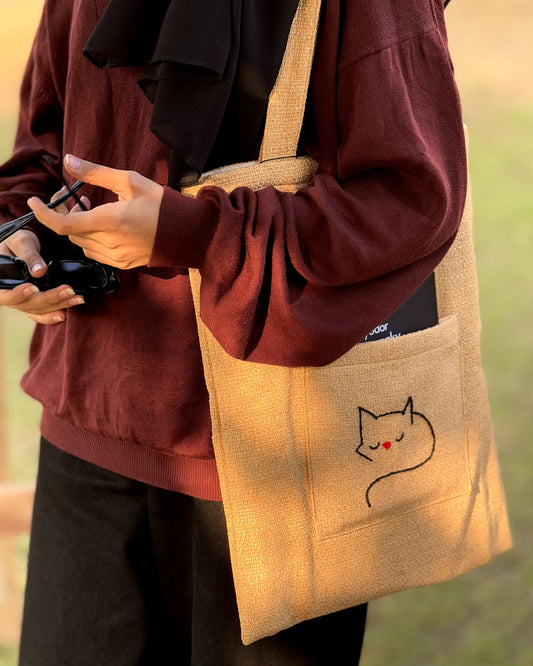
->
xmin=84 ymin=0 xmax=298 ymax=184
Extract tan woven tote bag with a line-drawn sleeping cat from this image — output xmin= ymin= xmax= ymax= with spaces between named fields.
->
xmin=186 ymin=0 xmax=511 ymax=644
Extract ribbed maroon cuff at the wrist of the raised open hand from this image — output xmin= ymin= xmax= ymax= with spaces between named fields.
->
xmin=148 ymin=186 xmax=218 ymax=268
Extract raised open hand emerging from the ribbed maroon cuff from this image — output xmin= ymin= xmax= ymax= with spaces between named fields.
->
xmin=28 ymin=155 xmax=163 ymax=269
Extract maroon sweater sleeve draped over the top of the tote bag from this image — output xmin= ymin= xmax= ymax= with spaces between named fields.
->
xmin=151 ymin=3 xmax=467 ymax=366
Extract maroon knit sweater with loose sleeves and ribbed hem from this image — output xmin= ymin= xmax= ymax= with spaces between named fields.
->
xmin=0 ymin=0 xmax=466 ymax=499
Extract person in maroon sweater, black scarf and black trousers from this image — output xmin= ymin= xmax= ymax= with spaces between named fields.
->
xmin=0 ymin=0 xmax=467 ymax=666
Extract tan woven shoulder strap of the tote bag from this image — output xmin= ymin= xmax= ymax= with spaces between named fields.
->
xmin=259 ymin=0 xmax=321 ymax=162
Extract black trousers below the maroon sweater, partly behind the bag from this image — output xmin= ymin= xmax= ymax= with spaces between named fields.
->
xmin=19 ymin=440 xmax=366 ymax=666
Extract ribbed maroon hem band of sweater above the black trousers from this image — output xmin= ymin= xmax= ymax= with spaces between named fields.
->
xmin=41 ymin=410 xmax=222 ymax=501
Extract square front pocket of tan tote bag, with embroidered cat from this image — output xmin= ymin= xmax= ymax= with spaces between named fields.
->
xmin=305 ymin=316 xmax=471 ymax=538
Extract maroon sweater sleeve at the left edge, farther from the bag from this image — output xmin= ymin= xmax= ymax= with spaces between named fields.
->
xmin=0 ymin=1 xmax=70 ymax=231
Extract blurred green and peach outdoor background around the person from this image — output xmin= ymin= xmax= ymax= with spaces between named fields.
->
xmin=0 ymin=0 xmax=533 ymax=666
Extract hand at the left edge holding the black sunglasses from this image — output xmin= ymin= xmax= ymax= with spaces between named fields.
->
xmin=0 ymin=227 xmax=84 ymax=324
